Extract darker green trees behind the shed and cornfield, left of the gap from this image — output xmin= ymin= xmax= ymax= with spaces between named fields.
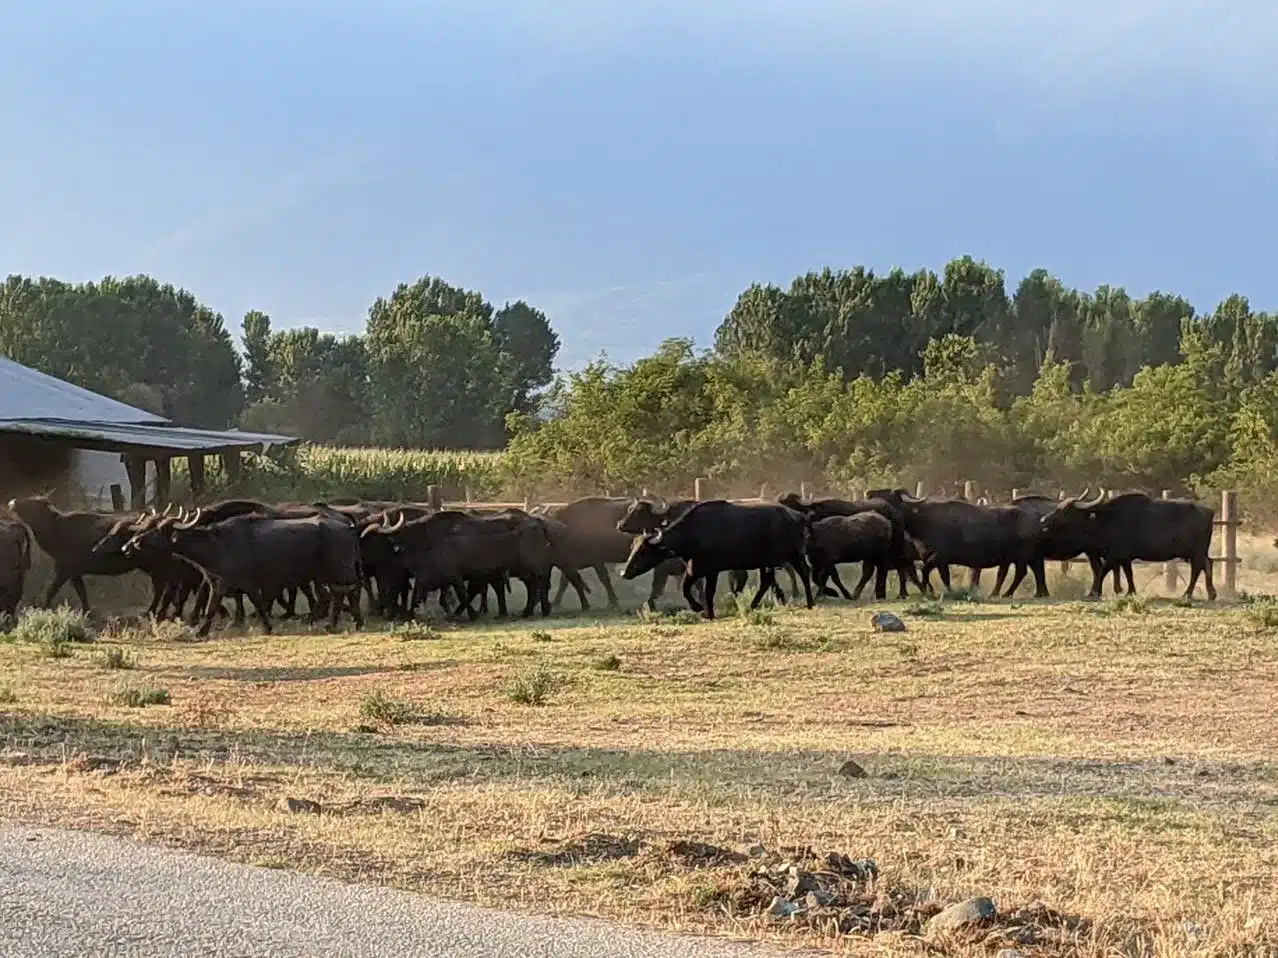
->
xmin=0 ymin=276 xmax=558 ymax=448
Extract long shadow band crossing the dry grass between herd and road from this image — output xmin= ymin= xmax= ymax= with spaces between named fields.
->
xmin=0 ymin=714 xmax=1278 ymax=816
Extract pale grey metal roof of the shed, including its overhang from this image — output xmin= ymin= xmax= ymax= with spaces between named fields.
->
xmin=0 ymin=356 xmax=298 ymax=453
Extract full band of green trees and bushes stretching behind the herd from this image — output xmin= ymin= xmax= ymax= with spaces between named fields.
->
xmin=0 ymin=257 xmax=1278 ymax=510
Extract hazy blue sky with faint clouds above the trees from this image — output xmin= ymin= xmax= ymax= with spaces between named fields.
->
xmin=0 ymin=0 xmax=1278 ymax=368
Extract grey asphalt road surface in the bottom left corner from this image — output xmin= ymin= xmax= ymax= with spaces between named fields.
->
xmin=0 ymin=825 xmax=781 ymax=958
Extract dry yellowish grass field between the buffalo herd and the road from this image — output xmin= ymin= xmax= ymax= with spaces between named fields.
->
xmin=0 ymin=574 xmax=1278 ymax=955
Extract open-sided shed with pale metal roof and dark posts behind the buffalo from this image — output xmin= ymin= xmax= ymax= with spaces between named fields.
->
xmin=0 ymin=356 xmax=298 ymax=510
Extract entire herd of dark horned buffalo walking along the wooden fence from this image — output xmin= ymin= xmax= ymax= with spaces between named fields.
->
xmin=0 ymin=489 xmax=1215 ymax=635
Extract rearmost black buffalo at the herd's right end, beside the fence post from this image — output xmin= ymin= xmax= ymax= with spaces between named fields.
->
xmin=1039 ymin=489 xmax=1215 ymax=599
